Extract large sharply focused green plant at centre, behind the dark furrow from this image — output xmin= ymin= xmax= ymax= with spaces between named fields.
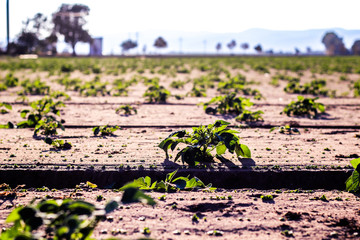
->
xmin=159 ymin=120 xmax=251 ymax=166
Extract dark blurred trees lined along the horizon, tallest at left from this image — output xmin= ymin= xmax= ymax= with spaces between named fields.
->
xmin=7 ymin=4 xmax=360 ymax=56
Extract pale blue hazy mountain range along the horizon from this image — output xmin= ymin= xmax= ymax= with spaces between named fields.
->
xmin=75 ymin=28 xmax=360 ymax=55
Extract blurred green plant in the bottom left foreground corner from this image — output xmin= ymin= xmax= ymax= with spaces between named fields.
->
xmin=0 ymin=187 xmax=156 ymax=240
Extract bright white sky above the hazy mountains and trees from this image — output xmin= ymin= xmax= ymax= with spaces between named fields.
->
xmin=0 ymin=0 xmax=360 ymax=54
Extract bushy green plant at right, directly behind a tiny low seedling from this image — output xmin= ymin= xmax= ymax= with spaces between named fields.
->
xmin=280 ymin=96 xmax=325 ymax=118
